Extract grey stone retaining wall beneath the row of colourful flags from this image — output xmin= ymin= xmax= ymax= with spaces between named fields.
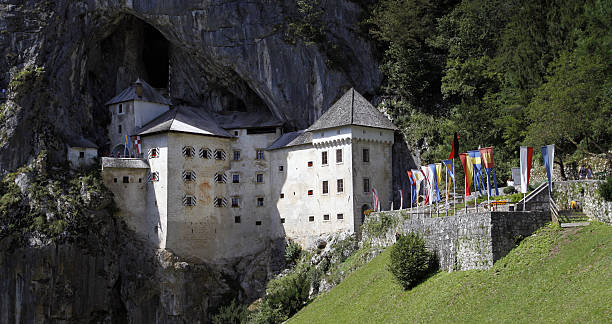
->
xmin=362 ymin=210 xmax=550 ymax=271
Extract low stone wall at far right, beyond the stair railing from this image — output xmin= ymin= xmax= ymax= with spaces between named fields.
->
xmin=553 ymin=180 xmax=612 ymax=224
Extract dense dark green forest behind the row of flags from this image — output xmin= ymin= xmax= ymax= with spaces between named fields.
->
xmin=363 ymin=0 xmax=612 ymax=181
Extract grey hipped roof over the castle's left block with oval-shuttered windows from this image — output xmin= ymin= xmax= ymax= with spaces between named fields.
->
xmin=136 ymin=106 xmax=233 ymax=137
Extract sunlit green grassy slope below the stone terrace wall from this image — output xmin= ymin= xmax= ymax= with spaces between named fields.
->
xmin=289 ymin=223 xmax=612 ymax=323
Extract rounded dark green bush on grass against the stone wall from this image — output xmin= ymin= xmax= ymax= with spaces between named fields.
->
xmin=387 ymin=233 xmax=438 ymax=290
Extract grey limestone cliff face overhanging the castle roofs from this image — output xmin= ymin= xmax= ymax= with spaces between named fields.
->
xmin=0 ymin=0 xmax=381 ymax=170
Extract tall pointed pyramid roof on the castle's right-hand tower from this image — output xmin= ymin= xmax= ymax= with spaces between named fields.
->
xmin=308 ymin=88 xmax=397 ymax=131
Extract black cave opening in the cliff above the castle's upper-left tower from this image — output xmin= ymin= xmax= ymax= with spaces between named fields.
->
xmin=142 ymin=23 xmax=170 ymax=88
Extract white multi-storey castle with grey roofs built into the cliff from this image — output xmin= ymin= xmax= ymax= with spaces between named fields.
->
xmin=102 ymin=80 xmax=397 ymax=263
